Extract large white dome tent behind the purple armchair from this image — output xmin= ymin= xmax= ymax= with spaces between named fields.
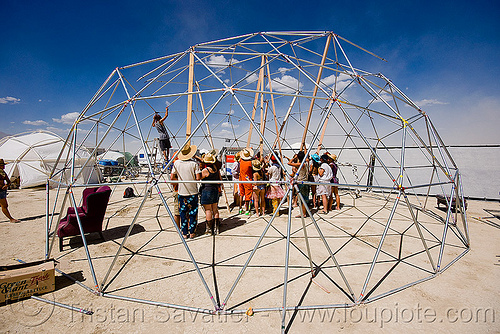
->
xmin=0 ymin=131 xmax=99 ymax=188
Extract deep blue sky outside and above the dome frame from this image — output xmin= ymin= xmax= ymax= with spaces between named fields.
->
xmin=0 ymin=0 xmax=500 ymax=144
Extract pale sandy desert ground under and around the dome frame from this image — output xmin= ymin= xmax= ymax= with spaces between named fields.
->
xmin=0 ymin=186 xmax=500 ymax=333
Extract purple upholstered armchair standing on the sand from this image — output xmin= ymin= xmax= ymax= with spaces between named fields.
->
xmin=57 ymin=186 xmax=111 ymax=251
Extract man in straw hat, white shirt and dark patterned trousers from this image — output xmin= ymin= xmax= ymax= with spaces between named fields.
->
xmin=171 ymin=144 xmax=201 ymax=239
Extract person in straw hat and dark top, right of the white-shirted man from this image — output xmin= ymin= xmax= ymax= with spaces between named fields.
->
xmin=200 ymin=153 xmax=221 ymax=235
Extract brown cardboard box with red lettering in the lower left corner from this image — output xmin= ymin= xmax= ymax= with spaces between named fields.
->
xmin=0 ymin=259 xmax=56 ymax=303
